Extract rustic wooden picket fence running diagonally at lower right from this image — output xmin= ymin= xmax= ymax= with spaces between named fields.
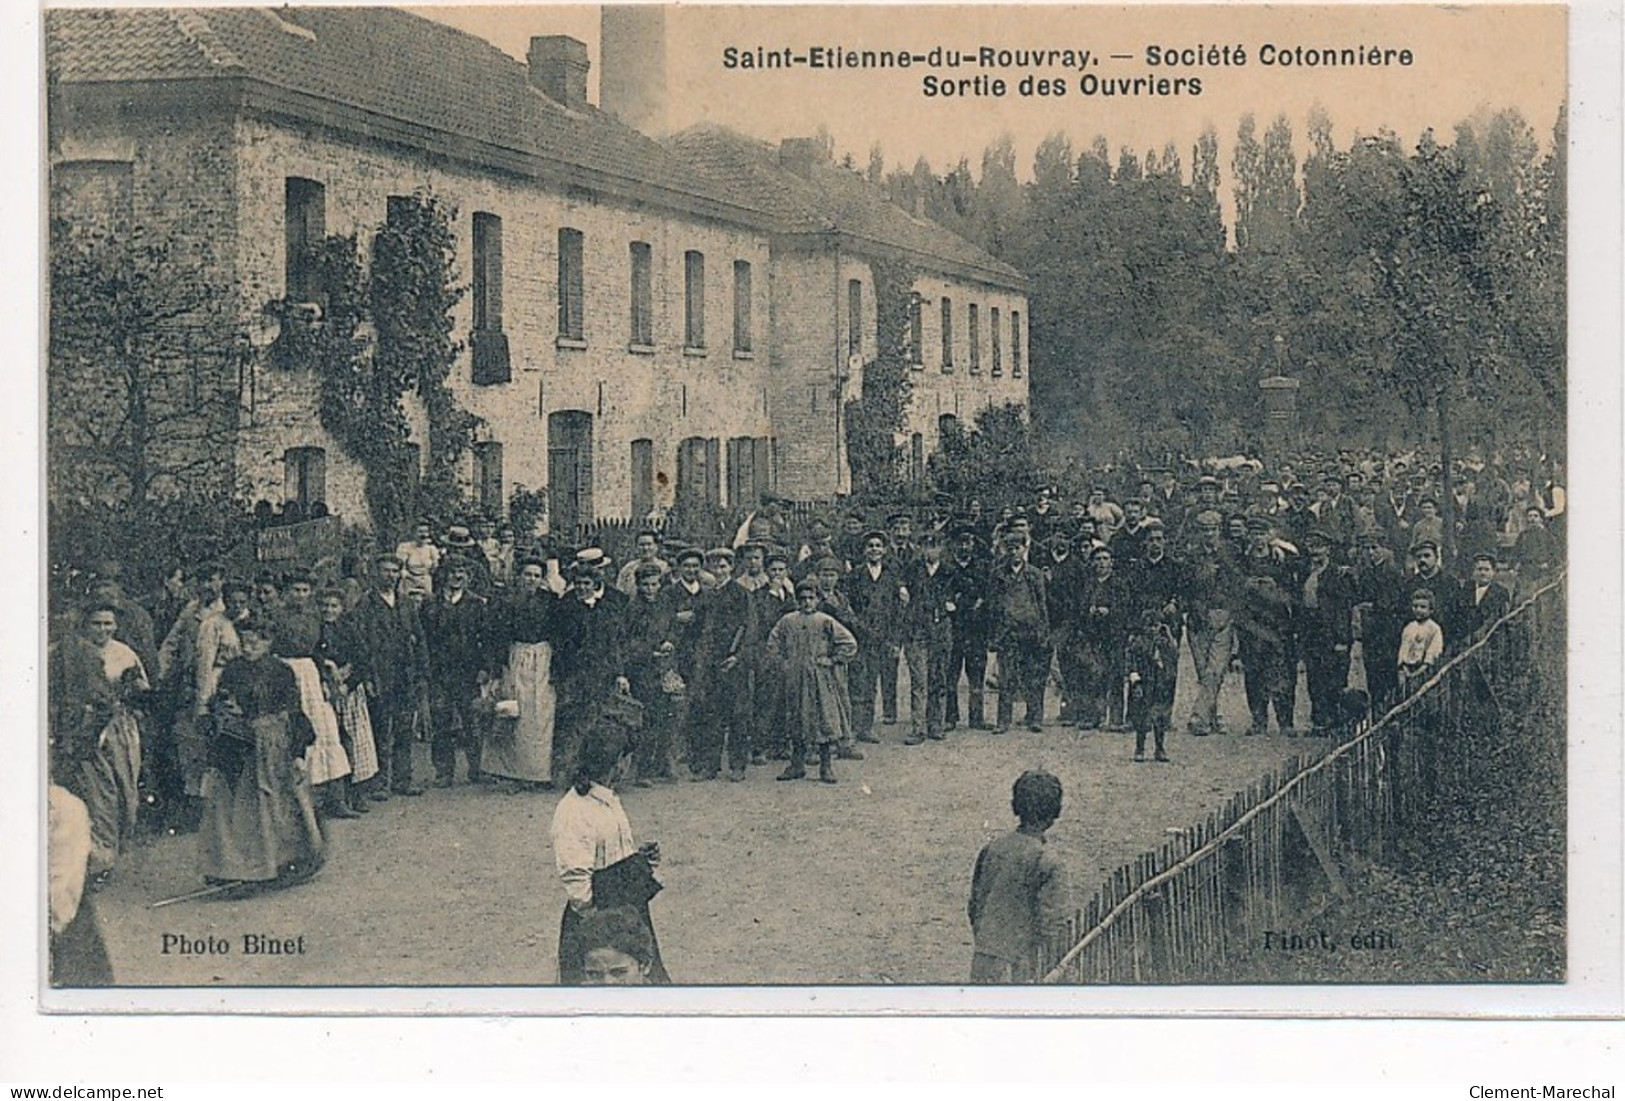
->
xmin=1038 ymin=576 xmax=1567 ymax=982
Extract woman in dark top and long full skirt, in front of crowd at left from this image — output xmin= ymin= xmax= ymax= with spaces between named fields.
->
xmin=198 ymin=619 xmax=327 ymax=887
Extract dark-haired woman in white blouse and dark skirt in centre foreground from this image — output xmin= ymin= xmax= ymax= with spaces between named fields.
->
xmin=553 ymin=739 xmax=671 ymax=986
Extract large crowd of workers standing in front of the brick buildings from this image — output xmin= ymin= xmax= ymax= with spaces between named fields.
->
xmin=49 ymin=453 xmax=1567 ymax=981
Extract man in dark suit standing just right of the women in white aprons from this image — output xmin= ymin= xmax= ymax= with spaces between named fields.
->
xmin=354 ymin=551 xmax=429 ymax=802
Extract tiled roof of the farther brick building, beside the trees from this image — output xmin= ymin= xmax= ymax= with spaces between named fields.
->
xmin=666 ymin=125 xmax=1024 ymax=286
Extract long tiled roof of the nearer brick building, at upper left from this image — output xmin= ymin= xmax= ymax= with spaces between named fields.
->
xmin=46 ymin=8 xmax=743 ymax=213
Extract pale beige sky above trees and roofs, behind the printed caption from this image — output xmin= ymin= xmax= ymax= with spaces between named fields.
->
xmin=419 ymin=5 xmax=1567 ymax=182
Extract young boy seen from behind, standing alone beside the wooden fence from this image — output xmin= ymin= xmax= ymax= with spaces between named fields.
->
xmin=970 ymin=771 xmax=1068 ymax=982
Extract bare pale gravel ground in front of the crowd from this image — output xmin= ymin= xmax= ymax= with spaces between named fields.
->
xmin=98 ymin=654 xmax=1324 ymax=986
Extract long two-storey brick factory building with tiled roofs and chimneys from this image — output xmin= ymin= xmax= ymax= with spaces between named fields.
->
xmin=47 ymin=8 xmax=1027 ymax=528
